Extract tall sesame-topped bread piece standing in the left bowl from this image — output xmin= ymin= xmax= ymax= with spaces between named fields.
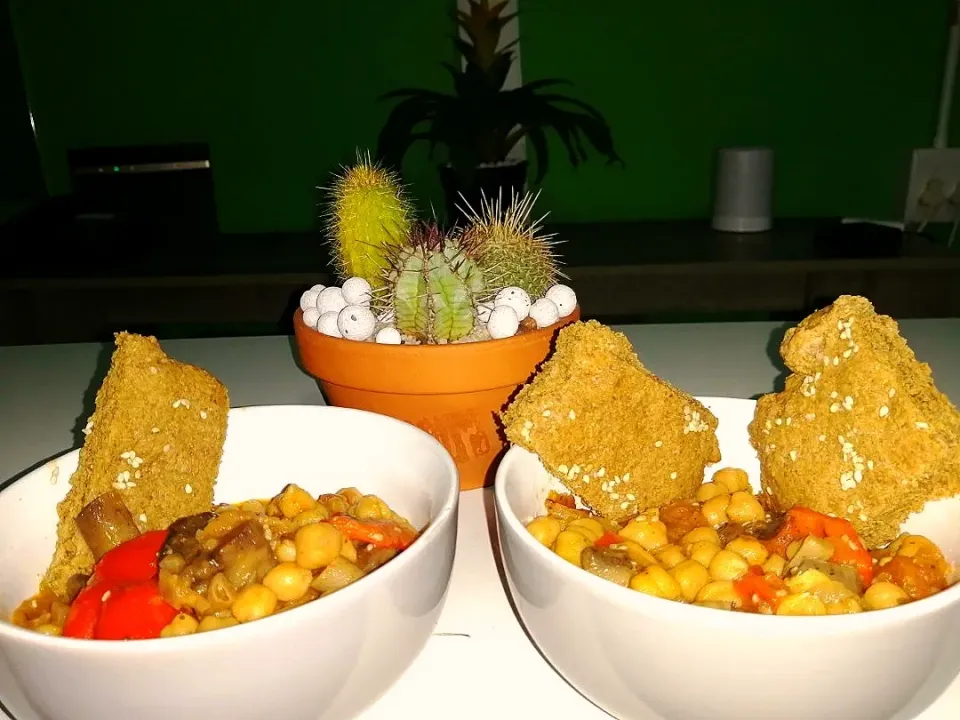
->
xmin=43 ymin=332 xmax=230 ymax=593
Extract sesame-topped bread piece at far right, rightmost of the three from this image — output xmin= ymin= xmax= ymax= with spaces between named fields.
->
xmin=749 ymin=295 xmax=960 ymax=547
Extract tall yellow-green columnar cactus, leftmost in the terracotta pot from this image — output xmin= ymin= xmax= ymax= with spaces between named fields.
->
xmin=327 ymin=153 xmax=412 ymax=287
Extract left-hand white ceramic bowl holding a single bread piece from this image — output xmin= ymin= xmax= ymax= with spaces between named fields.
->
xmin=0 ymin=406 xmax=459 ymax=720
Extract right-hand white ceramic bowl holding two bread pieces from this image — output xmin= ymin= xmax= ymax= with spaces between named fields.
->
xmin=495 ymin=398 xmax=960 ymax=720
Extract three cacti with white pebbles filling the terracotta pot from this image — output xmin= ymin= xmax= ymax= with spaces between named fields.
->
xmin=308 ymin=155 xmax=576 ymax=345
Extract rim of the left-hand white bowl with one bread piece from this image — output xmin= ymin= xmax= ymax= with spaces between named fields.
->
xmin=0 ymin=404 xmax=460 ymax=655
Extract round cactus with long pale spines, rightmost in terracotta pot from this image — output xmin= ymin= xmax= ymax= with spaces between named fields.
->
xmin=465 ymin=188 xmax=564 ymax=299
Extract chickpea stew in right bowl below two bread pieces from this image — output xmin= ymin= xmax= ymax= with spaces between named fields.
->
xmin=527 ymin=468 xmax=953 ymax=615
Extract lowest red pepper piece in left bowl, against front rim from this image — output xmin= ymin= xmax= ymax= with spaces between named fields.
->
xmin=94 ymin=580 xmax=178 ymax=640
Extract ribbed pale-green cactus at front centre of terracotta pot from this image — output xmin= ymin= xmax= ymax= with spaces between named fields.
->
xmin=376 ymin=225 xmax=495 ymax=343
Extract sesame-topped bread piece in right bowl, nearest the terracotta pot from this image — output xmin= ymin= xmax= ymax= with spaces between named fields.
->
xmin=501 ymin=320 xmax=720 ymax=520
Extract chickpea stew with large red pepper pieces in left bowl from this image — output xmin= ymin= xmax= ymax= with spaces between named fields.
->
xmin=12 ymin=484 xmax=419 ymax=640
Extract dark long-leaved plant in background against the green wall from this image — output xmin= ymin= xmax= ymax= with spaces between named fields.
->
xmin=378 ymin=0 xmax=620 ymax=182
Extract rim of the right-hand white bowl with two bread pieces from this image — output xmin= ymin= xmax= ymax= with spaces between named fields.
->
xmin=494 ymin=396 xmax=960 ymax=635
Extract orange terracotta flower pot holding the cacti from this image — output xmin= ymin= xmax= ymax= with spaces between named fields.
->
xmin=293 ymin=307 xmax=580 ymax=490
